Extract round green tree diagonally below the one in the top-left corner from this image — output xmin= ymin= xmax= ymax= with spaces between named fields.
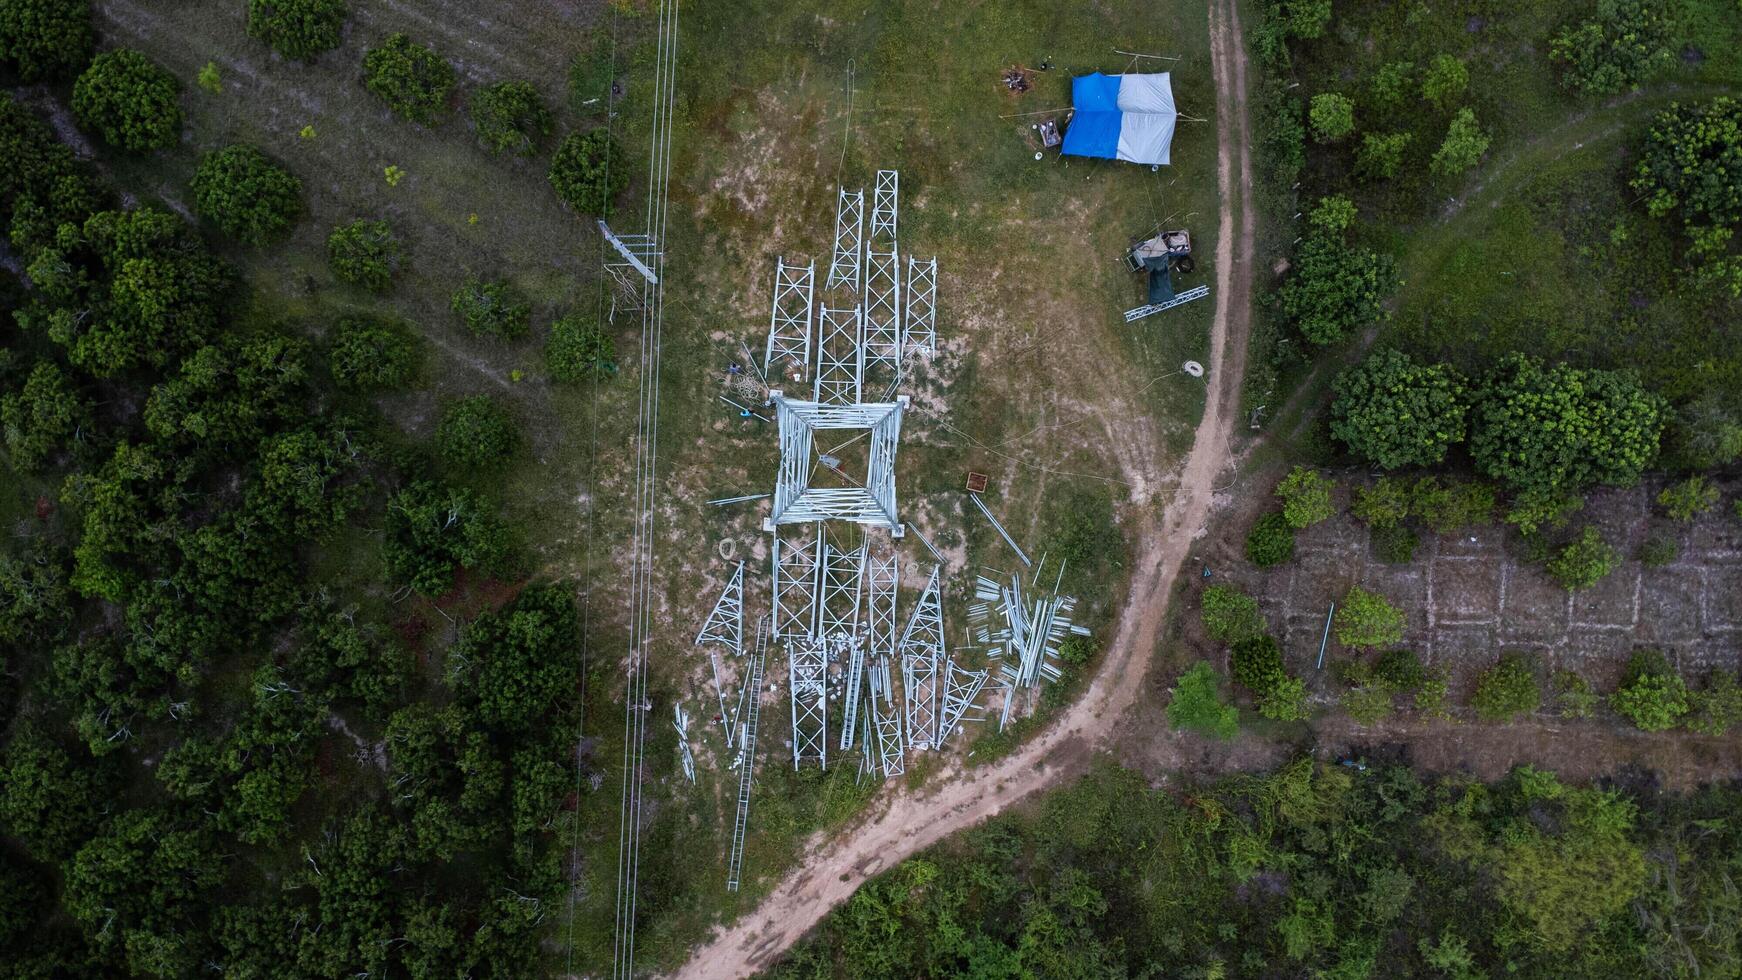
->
xmin=73 ymin=47 xmax=181 ymax=151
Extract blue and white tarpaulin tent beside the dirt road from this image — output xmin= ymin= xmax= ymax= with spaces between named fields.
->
xmin=1063 ymin=71 xmax=1179 ymax=164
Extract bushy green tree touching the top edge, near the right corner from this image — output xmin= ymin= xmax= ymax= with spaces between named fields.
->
xmin=1549 ymin=0 xmax=1674 ymax=96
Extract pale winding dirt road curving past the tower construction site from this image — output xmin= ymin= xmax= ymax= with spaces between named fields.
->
xmin=661 ymin=0 xmax=1256 ymax=978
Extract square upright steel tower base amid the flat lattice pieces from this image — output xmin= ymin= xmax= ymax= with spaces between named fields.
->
xmin=763 ymin=392 xmax=908 ymax=536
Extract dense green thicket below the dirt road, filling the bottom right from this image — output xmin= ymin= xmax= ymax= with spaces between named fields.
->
xmin=770 ymin=759 xmax=1742 ymax=978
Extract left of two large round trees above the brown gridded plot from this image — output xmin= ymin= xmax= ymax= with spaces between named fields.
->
xmin=1331 ymin=348 xmax=1467 ymax=470
